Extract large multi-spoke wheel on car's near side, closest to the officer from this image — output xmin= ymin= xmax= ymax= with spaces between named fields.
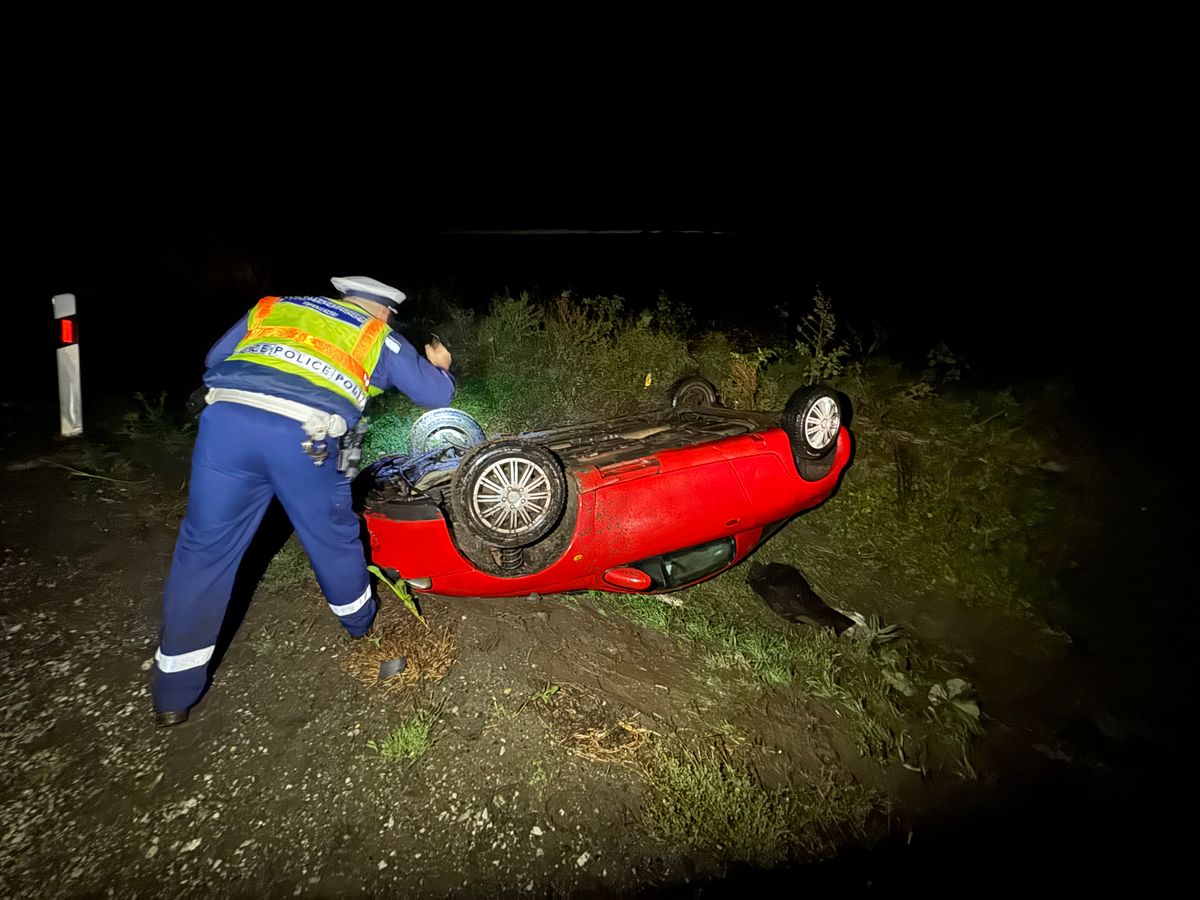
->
xmin=450 ymin=439 xmax=566 ymax=548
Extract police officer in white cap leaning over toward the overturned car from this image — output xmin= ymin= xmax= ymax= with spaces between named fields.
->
xmin=154 ymin=275 xmax=455 ymax=726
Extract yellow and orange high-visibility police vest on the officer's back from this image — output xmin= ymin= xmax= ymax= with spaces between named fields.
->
xmin=229 ymin=296 xmax=389 ymax=409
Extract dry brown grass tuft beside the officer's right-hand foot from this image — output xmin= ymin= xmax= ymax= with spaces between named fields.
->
xmin=347 ymin=602 xmax=458 ymax=694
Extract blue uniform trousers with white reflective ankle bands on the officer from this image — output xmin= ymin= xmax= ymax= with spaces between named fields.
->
xmin=154 ymin=402 xmax=377 ymax=710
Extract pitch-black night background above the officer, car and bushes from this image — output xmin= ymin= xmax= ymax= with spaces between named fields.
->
xmin=9 ymin=10 xmax=1192 ymax=434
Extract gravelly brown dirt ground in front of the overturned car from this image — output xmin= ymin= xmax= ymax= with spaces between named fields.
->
xmin=0 ymin=400 xmax=1176 ymax=898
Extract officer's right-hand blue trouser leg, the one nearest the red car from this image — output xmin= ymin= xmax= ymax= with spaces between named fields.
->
xmin=271 ymin=427 xmax=377 ymax=637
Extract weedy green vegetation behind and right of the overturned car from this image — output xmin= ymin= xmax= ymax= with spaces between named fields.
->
xmin=365 ymin=290 xmax=1049 ymax=619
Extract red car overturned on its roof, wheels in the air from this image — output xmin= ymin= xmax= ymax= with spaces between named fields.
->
xmin=355 ymin=377 xmax=853 ymax=596
